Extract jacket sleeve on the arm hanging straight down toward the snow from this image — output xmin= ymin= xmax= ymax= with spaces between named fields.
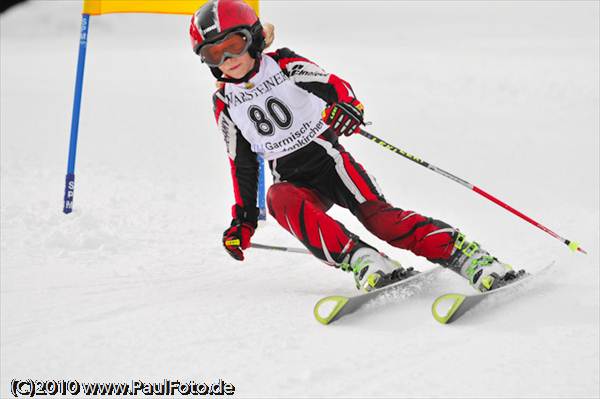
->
xmin=213 ymin=89 xmax=258 ymax=228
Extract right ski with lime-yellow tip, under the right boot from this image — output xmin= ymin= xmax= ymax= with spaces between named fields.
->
xmin=431 ymin=262 xmax=555 ymax=324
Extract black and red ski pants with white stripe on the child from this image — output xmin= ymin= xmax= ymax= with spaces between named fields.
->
xmin=267 ymin=136 xmax=456 ymax=264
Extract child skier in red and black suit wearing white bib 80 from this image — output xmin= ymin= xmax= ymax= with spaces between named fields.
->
xmin=190 ymin=0 xmax=518 ymax=291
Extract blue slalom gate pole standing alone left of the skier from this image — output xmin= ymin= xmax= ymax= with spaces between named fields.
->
xmin=63 ymin=14 xmax=90 ymax=214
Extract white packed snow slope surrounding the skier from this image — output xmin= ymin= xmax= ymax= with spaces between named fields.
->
xmin=0 ymin=1 xmax=600 ymax=398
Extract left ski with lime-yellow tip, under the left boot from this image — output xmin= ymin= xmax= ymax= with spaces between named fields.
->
xmin=313 ymin=267 xmax=441 ymax=325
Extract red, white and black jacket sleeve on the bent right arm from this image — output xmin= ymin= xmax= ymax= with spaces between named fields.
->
xmin=267 ymin=48 xmax=356 ymax=104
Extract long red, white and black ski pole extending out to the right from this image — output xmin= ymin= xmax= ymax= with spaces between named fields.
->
xmin=359 ymin=129 xmax=587 ymax=254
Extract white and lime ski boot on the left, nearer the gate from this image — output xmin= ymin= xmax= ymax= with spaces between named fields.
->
xmin=341 ymin=246 xmax=416 ymax=292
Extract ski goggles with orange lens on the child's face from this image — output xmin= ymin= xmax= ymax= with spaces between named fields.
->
xmin=197 ymin=29 xmax=252 ymax=68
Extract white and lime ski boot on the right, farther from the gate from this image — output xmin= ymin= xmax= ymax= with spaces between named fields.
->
xmin=446 ymin=233 xmax=526 ymax=292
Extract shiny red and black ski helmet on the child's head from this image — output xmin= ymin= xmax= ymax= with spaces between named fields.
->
xmin=190 ymin=0 xmax=265 ymax=58
